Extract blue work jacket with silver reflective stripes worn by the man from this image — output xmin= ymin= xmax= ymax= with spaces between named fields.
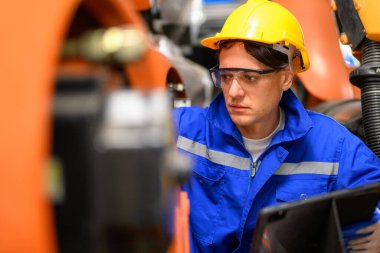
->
xmin=174 ymin=90 xmax=380 ymax=253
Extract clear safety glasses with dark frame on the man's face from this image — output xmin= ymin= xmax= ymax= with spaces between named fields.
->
xmin=210 ymin=66 xmax=276 ymax=88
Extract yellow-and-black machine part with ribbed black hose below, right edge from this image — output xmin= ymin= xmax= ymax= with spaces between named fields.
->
xmin=336 ymin=1 xmax=380 ymax=156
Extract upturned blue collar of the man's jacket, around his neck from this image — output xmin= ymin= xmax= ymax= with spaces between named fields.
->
xmin=208 ymin=89 xmax=313 ymax=142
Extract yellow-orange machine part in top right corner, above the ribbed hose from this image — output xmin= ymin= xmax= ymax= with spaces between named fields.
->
xmin=353 ymin=0 xmax=380 ymax=42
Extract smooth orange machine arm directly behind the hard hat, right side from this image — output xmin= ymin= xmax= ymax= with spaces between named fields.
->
xmin=274 ymin=0 xmax=360 ymax=105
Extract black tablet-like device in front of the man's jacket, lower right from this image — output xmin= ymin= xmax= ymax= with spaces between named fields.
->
xmin=251 ymin=183 xmax=380 ymax=253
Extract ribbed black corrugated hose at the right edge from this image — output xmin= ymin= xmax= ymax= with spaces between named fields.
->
xmin=350 ymin=39 xmax=380 ymax=157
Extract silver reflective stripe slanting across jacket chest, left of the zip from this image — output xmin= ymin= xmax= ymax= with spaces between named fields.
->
xmin=177 ymin=136 xmax=250 ymax=170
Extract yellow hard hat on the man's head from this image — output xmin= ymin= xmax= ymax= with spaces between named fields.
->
xmin=201 ymin=0 xmax=310 ymax=73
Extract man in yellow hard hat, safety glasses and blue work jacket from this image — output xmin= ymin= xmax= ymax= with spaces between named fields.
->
xmin=174 ymin=0 xmax=380 ymax=253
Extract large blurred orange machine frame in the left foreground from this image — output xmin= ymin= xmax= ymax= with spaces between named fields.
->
xmin=0 ymin=0 xmax=186 ymax=253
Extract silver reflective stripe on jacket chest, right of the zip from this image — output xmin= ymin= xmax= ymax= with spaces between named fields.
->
xmin=274 ymin=162 xmax=339 ymax=175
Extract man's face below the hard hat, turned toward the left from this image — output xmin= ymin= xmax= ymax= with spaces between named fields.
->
xmin=219 ymin=43 xmax=293 ymax=138
